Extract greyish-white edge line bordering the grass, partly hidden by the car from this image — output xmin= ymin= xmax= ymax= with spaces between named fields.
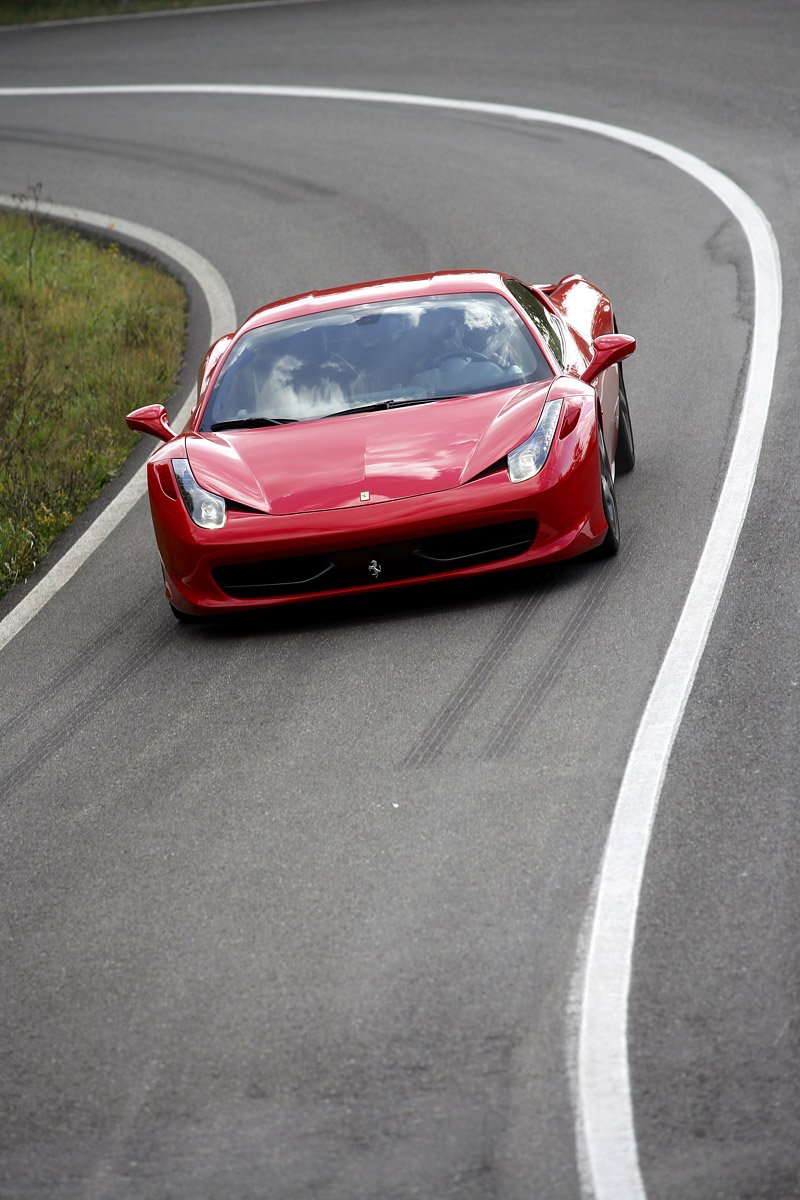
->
xmin=0 ymin=196 xmax=236 ymax=650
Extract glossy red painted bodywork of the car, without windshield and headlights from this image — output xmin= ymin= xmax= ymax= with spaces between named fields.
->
xmin=132 ymin=271 xmax=630 ymax=616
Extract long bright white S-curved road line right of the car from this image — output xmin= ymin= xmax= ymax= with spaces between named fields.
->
xmin=0 ymin=84 xmax=782 ymax=1200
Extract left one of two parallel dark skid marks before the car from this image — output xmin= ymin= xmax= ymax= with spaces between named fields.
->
xmin=403 ymin=570 xmax=554 ymax=767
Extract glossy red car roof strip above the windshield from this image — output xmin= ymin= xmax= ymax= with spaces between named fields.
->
xmin=240 ymin=271 xmax=506 ymax=332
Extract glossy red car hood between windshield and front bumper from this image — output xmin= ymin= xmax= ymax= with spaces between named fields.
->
xmin=186 ymin=380 xmax=552 ymax=516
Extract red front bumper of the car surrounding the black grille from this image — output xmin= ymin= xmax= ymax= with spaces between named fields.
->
xmin=149 ymin=418 xmax=607 ymax=616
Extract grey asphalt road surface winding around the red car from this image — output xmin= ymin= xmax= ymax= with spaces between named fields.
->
xmin=0 ymin=0 xmax=800 ymax=1200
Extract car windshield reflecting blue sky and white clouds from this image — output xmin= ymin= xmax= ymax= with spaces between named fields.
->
xmin=200 ymin=293 xmax=553 ymax=430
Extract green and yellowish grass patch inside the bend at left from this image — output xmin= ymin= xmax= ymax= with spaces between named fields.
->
xmin=0 ymin=197 xmax=186 ymax=595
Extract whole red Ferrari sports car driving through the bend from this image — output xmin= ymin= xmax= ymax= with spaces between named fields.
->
xmin=127 ymin=271 xmax=636 ymax=619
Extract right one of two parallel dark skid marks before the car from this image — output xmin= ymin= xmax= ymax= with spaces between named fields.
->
xmin=483 ymin=530 xmax=636 ymax=758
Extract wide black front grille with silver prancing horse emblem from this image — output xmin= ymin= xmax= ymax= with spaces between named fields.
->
xmin=211 ymin=521 xmax=536 ymax=599
